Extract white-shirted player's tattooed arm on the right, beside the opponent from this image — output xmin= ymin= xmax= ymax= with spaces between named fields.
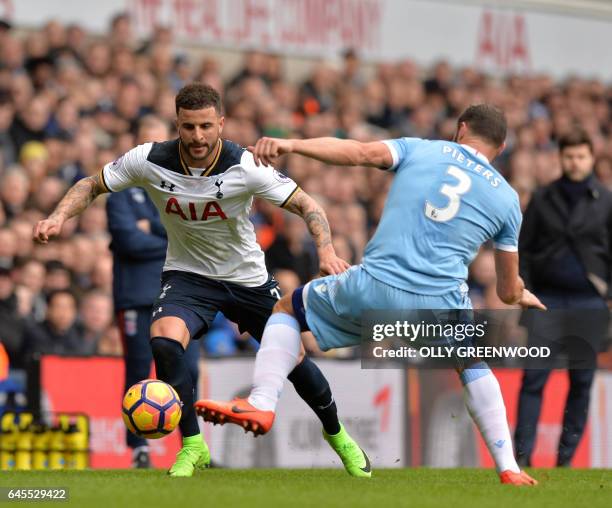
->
xmin=284 ymin=189 xmax=350 ymax=275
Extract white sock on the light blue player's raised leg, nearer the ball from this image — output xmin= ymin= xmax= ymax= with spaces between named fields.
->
xmin=248 ymin=312 xmax=302 ymax=411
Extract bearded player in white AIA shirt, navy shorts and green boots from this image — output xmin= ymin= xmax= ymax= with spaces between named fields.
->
xmin=33 ymin=83 xmax=370 ymax=476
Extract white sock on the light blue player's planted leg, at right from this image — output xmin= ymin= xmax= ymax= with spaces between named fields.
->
xmin=461 ymin=362 xmax=520 ymax=473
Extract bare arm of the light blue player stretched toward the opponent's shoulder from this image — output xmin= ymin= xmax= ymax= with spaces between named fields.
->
xmin=248 ymin=138 xmax=393 ymax=169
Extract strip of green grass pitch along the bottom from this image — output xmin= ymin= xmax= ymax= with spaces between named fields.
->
xmin=0 ymin=468 xmax=612 ymax=508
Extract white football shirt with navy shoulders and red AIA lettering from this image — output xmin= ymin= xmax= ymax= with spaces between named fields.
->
xmin=101 ymin=139 xmax=299 ymax=287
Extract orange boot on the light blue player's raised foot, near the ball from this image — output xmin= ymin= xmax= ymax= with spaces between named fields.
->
xmin=194 ymin=399 xmax=274 ymax=437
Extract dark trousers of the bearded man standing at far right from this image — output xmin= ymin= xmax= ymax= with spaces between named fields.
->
xmin=514 ymin=293 xmax=607 ymax=466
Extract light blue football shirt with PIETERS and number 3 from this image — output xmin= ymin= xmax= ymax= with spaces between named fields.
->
xmin=363 ymin=138 xmax=522 ymax=295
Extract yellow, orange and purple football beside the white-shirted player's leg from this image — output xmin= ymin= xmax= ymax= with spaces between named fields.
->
xmin=123 ymin=379 xmax=182 ymax=439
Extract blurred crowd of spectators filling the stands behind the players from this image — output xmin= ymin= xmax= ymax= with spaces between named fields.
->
xmin=0 ymin=15 xmax=612 ymax=366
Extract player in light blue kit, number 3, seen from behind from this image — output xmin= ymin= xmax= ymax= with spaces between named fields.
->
xmin=198 ymin=104 xmax=545 ymax=485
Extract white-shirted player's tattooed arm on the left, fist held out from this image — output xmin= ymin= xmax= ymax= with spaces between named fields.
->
xmin=33 ymin=174 xmax=108 ymax=243
